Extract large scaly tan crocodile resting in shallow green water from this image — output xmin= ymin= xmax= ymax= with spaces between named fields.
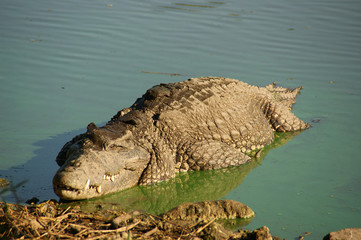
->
xmin=53 ymin=77 xmax=311 ymax=200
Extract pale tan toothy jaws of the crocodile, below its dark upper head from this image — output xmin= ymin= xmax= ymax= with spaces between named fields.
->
xmin=53 ymin=147 xmax=149 ymax=200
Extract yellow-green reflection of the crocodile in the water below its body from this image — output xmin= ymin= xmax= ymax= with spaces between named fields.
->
xmin=72 ymin=132 xmax=299 ymax=214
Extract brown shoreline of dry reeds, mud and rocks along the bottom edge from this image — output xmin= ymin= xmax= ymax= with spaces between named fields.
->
xmin=0 ymin=200 xmax=361 ymax=240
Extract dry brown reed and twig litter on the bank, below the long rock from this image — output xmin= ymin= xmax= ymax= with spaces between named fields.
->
xmin=0 ymin=200 xmax=272 ymax=239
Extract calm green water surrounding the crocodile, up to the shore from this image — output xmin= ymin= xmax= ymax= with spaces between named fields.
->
xmin=0 ymin=0 xmax=361 ymax=239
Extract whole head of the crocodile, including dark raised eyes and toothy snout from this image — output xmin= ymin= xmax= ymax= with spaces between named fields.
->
xmin=53 ymin=123 xmax=149 ymax=200
